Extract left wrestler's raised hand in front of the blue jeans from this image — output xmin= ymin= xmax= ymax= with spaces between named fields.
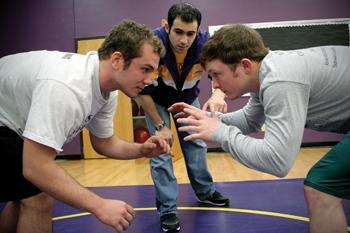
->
xmin=140 ymin=136 xmax=172 ymax=158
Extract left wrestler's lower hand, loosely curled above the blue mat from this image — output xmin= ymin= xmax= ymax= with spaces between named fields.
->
xmin=96 ymin=199 xmax=135 ymax=233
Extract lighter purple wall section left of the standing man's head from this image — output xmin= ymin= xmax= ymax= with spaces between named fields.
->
xmin=75 ymin=0 xmax=176 ymax=38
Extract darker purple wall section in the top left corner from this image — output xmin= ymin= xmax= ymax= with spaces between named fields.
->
xmin=0 ymin=0 xmax=75 ymax=57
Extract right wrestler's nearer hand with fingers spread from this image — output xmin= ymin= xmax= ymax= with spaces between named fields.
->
xmin=177 ymin=105 xmax=222 ymax=141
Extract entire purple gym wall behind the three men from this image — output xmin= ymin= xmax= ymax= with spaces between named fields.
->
xmin=0 ymin=0 xmax=350 ymax=154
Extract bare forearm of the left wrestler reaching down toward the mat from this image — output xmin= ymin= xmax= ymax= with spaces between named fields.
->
xmin=23 ymin=139 xmax=102 ymax=214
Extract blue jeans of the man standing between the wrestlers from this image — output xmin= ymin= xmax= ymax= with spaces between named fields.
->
xmin=146 ymin=99 xmax=215 ymax=215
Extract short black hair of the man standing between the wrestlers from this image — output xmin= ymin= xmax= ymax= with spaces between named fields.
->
xmin=168 ymin=3 xmax=202 ymax=28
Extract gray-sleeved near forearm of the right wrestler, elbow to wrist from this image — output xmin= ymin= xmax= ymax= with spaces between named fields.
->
xmin=214 ymin=124 xmax=299 ymax=177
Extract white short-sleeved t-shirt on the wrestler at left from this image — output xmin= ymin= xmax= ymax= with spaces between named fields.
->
xmin=0 ymin=51 xmax=116 ymax=152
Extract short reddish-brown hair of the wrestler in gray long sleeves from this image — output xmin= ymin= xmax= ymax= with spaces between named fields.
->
xmin=201 ymin=24 xmax=268 ymax=67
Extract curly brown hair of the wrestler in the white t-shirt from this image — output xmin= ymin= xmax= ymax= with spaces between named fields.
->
xmin=98 ymin=20 xmax=165 ymax=67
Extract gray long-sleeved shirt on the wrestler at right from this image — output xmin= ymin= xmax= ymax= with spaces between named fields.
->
xmin=214 ymin=46 xmax=350 ymax=176
